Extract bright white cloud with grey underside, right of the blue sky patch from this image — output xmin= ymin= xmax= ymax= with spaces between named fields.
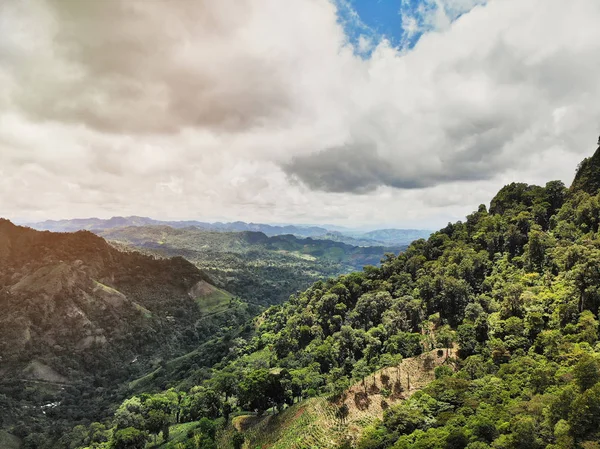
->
xmin=284 ymin=1 xmax=600 ymax=193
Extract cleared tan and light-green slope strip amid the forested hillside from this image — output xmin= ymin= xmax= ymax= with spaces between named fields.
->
xmin=219 ymin=349 xmax=456 ymax=449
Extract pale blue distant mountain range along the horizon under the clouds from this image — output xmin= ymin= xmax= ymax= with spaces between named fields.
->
xmin=27 ymin=216 xmax=431 ymax=247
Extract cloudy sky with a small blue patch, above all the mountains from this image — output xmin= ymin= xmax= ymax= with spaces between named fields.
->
xmin=0 ymin=0 xmax=600 ymax=229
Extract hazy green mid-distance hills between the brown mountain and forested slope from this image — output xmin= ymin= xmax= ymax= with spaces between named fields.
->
xmin=96 ymin=226 xmax=402 ymax=305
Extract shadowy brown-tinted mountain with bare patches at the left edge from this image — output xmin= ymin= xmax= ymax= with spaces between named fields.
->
xmin=0 ymin=219 xmax=250 ymax=436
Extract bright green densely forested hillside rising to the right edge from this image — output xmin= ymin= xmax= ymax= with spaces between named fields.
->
xmin=64 ymin=144 xmax=600 ymax=449
